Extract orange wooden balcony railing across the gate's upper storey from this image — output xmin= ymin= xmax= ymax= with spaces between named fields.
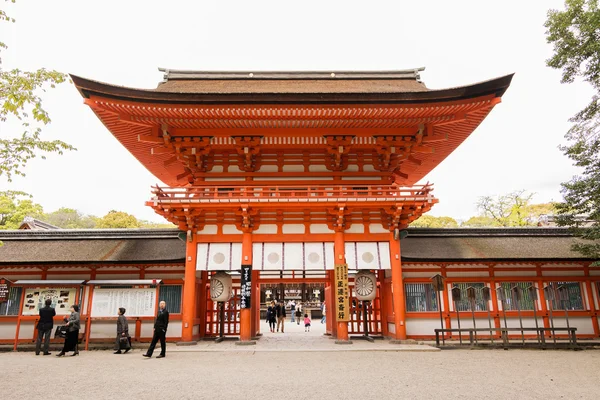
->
xmin=151 ymin=185 xmax=437 ymax=203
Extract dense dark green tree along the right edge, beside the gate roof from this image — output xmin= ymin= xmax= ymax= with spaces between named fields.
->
xmin=545 ymin=0 xmax=600 ymax=259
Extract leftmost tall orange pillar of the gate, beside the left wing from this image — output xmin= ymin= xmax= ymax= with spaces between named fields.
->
xmin=181 ymin=231 xmax=198 ymax=342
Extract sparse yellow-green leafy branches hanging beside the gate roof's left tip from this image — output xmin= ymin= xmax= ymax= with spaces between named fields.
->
xmin=0 ymin=0 xmax=75 ymax=182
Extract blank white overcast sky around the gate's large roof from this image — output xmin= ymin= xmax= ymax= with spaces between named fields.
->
xmin=0 ymin=0 xmax=591 ymax=221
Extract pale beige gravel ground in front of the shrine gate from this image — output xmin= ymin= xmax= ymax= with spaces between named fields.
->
xmin=0 ymin=350 xmax=600 ymax=400
